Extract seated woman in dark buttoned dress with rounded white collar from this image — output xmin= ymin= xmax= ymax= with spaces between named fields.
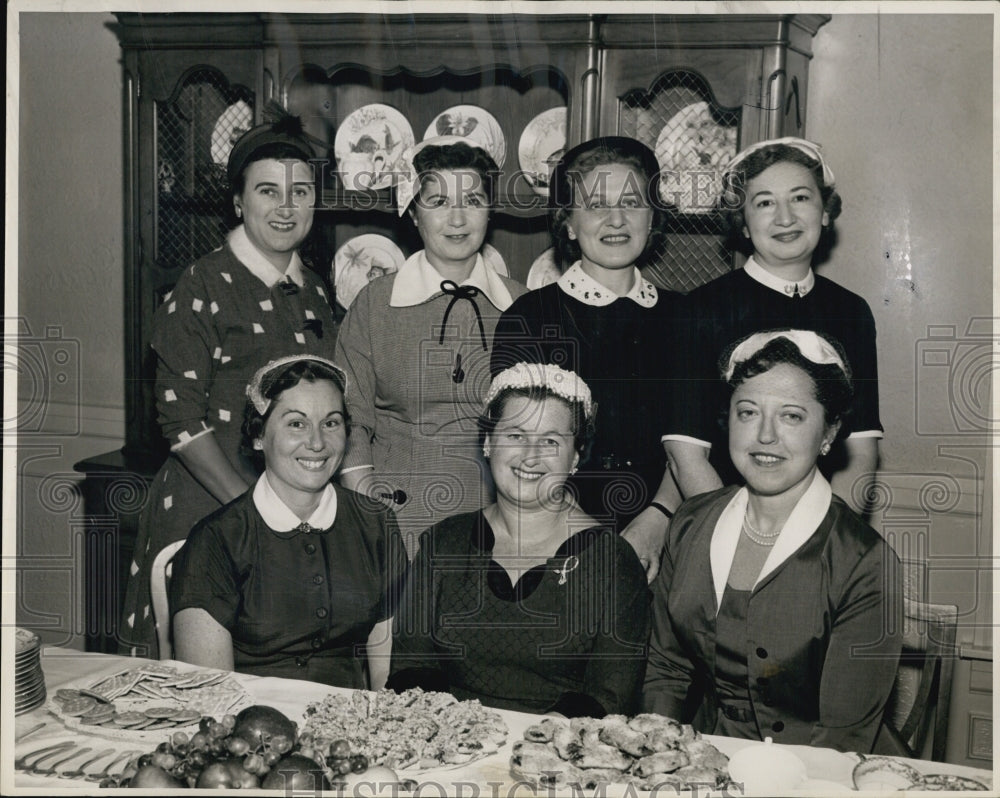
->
xmin=170 ymin=355 xmax=406 ymax=688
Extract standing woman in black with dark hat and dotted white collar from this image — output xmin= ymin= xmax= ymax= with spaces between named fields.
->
xmin=490 ymin=136 xmax=680 ymax=578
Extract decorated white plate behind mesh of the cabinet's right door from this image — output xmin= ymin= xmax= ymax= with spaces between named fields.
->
xmin=655 ymin=101 xmax=737 ymax=213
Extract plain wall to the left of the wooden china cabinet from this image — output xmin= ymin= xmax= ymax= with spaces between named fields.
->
xmin=15 ymin=13 xmax=125 ymax=646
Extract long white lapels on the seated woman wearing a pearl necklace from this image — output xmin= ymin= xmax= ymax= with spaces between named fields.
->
xmin=710 ymin=469 xmax=833 ymax=613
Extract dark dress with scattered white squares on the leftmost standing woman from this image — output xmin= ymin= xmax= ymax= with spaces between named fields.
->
xmin=119 ymin=234 xmax=337 ymax=659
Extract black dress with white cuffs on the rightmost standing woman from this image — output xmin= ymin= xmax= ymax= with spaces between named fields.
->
xmin=669 ymin=269 xmax=882 ymax=485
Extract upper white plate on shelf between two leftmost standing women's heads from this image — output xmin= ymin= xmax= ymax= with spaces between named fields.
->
xmin=333 ymin=103 xmax=414 ymax=191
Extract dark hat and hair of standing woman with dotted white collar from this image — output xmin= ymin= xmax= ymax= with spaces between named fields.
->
xmin=549 ymin=137 xmax=666 ymax=268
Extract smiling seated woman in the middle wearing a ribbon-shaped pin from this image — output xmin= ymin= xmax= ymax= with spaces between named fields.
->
xmin=389 ymin=363 xmax=649 ymax=717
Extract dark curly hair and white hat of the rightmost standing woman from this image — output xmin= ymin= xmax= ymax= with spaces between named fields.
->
xmin=720 ymin=144 xmax=842 ymax=255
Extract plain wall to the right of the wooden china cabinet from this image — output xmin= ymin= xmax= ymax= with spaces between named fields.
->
xmin=806 ymin=14 xmax=995 ymax=647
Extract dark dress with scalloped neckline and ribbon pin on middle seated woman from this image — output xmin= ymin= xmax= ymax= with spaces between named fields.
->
xmin=389 ymin=511 xmax=649 ymax=717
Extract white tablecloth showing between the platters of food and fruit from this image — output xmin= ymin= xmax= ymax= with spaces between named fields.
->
xmin=0 ymin=647 xmax=992 ymax=798
